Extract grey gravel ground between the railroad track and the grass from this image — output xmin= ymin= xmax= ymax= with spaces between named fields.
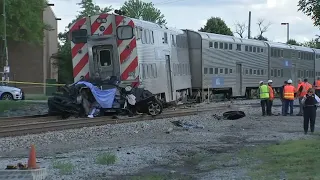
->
xmin=0 ymin=100 xmax=320 ymax=180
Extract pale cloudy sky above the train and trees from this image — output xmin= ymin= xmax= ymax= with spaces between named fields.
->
xmin=49 ymin=0 xmax=320 ymax=42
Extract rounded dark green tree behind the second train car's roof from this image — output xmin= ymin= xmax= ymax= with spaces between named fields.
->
xmin=199 ymin=17 xmax=233 ymax=36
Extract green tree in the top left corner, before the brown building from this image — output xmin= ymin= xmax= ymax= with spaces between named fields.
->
xmin=0 ymin=0 xmax=50 ymax=44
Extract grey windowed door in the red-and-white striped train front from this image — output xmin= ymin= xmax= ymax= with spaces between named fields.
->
xmin=92 ymin=45 xmax=118 ymax=79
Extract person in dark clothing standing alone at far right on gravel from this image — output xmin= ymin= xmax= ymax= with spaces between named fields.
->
xmin=301 ymin=88 xmax=320 ymax=134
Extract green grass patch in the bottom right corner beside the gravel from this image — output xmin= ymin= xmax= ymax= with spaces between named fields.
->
xmin=240 ymin=139 xmax=320 ymax=180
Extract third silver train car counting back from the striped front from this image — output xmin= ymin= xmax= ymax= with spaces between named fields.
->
xmin=267 ymin=42 xmax=297 ymax=90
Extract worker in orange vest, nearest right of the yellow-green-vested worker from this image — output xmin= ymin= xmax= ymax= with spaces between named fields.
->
xmin=283 ymin=79 xmax=295 ymax=116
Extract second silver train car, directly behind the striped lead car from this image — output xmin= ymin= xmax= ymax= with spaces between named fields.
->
xmin=185 ymin=30 xmax=269 ymax=98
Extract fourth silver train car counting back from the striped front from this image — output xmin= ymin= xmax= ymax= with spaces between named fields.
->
xmin=293 ymin=46 xmax=315 ymax=84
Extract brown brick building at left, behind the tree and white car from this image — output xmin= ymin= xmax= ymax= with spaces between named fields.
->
xmin=8 ymin=6 xmax=58 ymax=93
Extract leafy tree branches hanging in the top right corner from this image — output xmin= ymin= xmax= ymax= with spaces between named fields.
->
xmin=298 ymin=0 xmax=320 ymax=26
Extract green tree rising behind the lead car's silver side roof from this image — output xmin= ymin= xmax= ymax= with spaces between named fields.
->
xmin=120 ymin=0 xmax=167 ymax=25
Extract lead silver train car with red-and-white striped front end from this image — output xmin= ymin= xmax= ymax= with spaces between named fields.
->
xmin=69 ymin=13 xmax=191 ymax=102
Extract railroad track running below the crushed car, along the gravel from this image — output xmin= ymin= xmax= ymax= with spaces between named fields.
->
xmin=0 ymin=106 xmax=235 ymax=137
